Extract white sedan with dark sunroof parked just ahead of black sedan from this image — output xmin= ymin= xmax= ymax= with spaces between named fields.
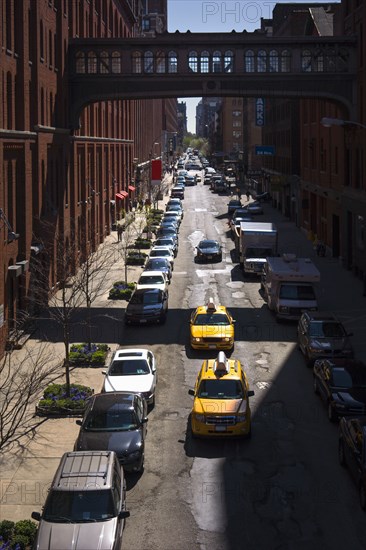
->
xmin=102 ymin=348 xmax=157 ymax=406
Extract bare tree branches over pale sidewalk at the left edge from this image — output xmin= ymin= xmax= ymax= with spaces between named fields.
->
xmin=0 ymin=343 xmax=62 ymax=452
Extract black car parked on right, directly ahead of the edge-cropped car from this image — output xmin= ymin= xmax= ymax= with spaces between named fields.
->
xmin=313 ymin=358 xmax=366 ymax=422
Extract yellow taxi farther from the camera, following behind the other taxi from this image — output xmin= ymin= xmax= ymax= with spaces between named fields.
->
xmin=190 ymin=298 xmax=235 ymax=350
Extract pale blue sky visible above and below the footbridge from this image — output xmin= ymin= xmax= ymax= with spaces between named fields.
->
xmin=168 ymin=0 xmax=340 ymax=133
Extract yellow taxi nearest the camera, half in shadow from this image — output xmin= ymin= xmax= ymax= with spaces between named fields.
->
xmin=188 ymin=351 xmax=254 ymax=437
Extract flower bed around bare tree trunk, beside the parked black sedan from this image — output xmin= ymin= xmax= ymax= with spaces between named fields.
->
xmin=36 ymin=384 xmax=94 ymax=416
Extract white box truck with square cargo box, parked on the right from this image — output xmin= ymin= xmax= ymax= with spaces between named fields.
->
xmin=237 ymin=222 xmax=278 ymax=275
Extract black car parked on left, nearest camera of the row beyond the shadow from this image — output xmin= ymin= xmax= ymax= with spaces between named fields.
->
xmin=125 ymin=286 xmax=168 ymax=325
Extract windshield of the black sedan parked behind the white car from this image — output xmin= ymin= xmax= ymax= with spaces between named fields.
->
xmin=83 ymin=412 xmax=138 ymax=432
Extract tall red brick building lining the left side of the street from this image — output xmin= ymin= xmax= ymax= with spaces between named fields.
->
xmin=0 ymin=0 xmax=177 ymax=355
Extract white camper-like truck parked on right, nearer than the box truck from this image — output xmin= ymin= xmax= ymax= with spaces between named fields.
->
xmin=262 ymin=254 xmax=320 ymax=320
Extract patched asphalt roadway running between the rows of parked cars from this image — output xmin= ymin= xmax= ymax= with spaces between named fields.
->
xmin=119 ymin=185 xmax=366 ymax=550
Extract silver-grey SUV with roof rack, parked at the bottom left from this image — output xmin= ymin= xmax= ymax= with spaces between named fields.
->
xmin=32 ymin=451 xmax=130 ymax=550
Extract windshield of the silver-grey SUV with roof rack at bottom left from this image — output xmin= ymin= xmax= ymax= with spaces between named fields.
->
xmin=42 ymin=492 xmax=118 ymax=523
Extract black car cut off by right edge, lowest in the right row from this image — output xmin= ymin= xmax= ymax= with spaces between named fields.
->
xmin=338 ymin=417 xmax=366 ymax=510
